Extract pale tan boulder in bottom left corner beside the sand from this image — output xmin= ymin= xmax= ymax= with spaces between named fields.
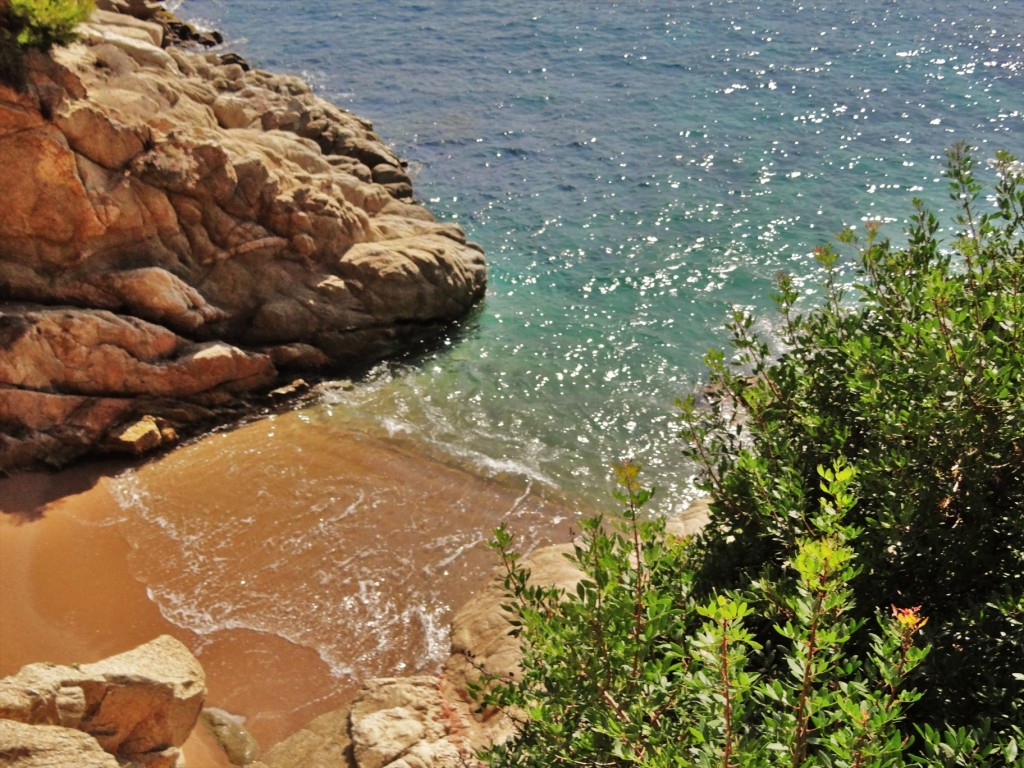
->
xmin=0 ymin=636 xmax=206 ymax=768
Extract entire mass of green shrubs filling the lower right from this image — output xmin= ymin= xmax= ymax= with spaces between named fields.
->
xmin=478 ymin=146 xmax=1024 ymax=768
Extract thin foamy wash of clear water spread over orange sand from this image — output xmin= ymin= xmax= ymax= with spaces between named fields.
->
xmin=110 ymin=412 xmax=569 ymax=679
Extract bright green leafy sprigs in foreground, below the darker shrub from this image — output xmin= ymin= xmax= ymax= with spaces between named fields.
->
xmin=475 ymin=462 xmax=1017 ymax=768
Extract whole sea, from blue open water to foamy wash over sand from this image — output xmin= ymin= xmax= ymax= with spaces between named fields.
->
xmin=103 ymin=0 xmax=1024 ymax=688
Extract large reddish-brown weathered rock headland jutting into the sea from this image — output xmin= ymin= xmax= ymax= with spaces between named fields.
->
xmin=0 ymin=3 xmax=485 ymax=469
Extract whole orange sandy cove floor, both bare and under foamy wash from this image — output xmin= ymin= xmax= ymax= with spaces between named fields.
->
xmin=0 ymin=423 xmax=571 ymax=746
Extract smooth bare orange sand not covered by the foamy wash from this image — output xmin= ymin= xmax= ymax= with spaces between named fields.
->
xmin=0 ymin=462 xmax=355 ymax=767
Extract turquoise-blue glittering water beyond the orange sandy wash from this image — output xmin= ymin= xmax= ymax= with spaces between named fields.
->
xmin=177 ymin=0 xmax=1024 ymax=518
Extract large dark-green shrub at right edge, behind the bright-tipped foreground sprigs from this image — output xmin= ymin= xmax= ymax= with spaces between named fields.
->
xmin=682 ymin=141 xmax=1024 ymax=728
